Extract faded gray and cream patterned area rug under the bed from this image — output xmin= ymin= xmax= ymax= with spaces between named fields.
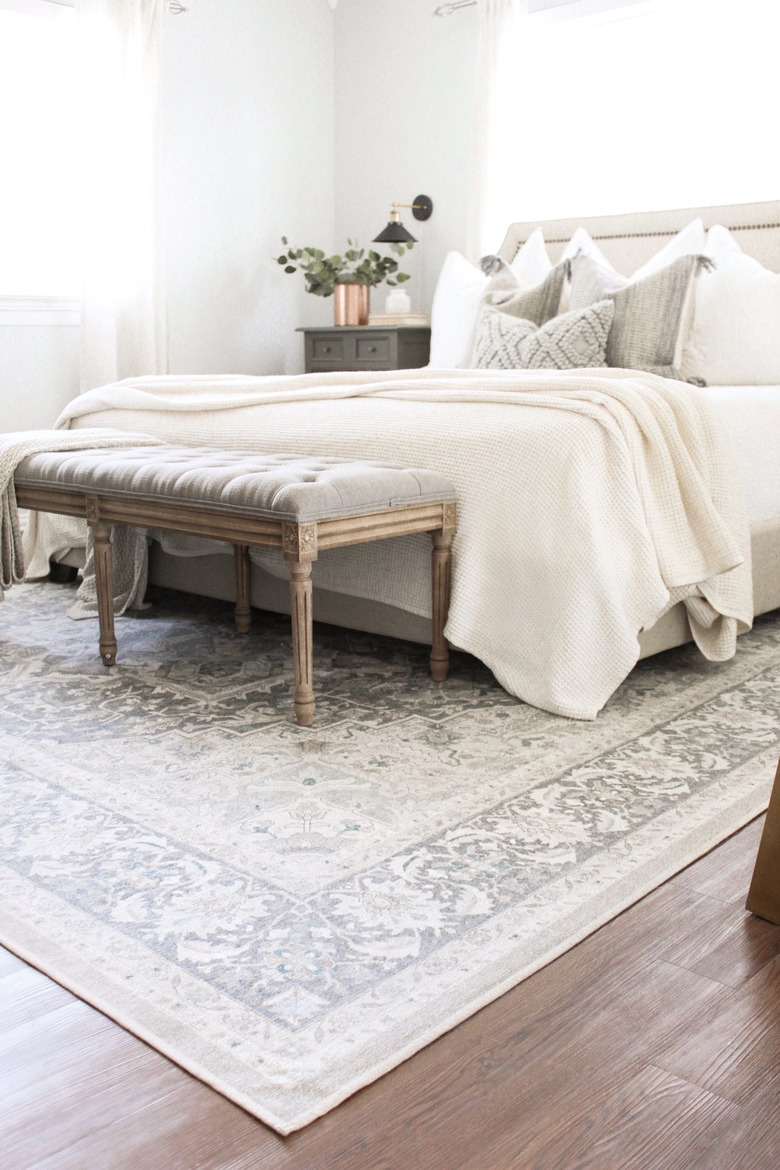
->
xmin=0 ymin=584 xmax=780 ymax=1133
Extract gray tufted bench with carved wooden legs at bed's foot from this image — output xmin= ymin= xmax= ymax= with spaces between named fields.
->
xmin=14 ymin=446 xmax=456 ymax=727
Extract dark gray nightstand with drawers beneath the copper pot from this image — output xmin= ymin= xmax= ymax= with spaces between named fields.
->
xmin=297 ymin=325 xmax=430 ymax=373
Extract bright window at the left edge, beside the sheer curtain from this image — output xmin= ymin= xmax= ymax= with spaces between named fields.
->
xmin=0 ymin=0 xmax=80 ymax=298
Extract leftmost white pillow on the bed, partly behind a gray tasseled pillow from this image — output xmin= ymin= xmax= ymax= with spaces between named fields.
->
xmin=428 ymin=228 xmax=552 ymax=370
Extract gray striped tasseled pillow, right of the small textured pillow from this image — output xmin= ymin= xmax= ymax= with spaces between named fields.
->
xmin=568 ymin=252 xmax=705 ymax=378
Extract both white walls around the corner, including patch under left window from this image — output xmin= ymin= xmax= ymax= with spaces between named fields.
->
xmin=0 ymin=0 xmax=488 ymax=429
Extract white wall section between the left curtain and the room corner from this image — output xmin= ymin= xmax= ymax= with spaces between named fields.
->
xmin=163 ymin=0 xmax=333 ymax=374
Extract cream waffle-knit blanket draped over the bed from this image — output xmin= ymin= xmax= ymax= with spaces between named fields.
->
xmin=22 ymin=370 xmax=752 ymax=718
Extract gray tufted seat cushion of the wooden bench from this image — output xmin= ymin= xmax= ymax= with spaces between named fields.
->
xmin=14 ymin=446 xmax=455 ymax=522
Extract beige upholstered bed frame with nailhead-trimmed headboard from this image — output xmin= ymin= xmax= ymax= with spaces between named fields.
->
xmin=150 ymin=201 xmax=780 ymax=658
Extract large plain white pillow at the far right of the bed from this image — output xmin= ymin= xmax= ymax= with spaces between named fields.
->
xmin=683 ymin=225 xmax=780 ymax=386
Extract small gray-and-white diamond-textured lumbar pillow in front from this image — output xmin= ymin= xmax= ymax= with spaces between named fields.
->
xmin=471 ymin=300 xmax=615 ymax=370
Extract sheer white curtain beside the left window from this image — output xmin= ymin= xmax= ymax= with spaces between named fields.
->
xmin=76 ymin=0 xmax=167 ymax=390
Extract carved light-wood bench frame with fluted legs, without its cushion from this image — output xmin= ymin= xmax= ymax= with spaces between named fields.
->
xmin=16 ymin=484 xmax=457 ymax=727
